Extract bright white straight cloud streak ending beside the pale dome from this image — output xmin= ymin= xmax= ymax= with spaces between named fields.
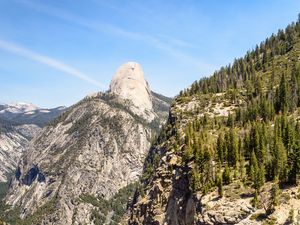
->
xmin=0 ymin=39 xmax=106 ymax=88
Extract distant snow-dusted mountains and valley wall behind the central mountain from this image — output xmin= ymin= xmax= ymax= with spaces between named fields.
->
xmin=0 ymin=103 xmax=65 ymax=182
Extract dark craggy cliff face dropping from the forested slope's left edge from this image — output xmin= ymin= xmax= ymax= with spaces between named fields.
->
xmin=124 ymin=103 xmax=200 ymax=225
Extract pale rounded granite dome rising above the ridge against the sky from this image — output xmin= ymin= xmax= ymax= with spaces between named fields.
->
xmin=109 ymin=62 xmax=154 ymax=121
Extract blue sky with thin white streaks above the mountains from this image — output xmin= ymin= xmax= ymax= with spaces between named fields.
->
xmin=0 ymin=0 xmax=300 ymax=107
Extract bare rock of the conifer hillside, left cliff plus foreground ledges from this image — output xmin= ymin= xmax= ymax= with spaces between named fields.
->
xmin=127 ymin=91 xmax=300 ymax=225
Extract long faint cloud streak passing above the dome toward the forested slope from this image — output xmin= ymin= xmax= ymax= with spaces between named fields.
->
xmin=15 ymin=0 xmax=214 ymax=73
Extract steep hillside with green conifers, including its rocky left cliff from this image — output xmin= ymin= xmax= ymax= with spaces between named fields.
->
xmin=130 ymin=17 xmax=300 ymax=224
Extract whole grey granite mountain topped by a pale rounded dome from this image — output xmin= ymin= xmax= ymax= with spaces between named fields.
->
xmin=6 ymin=64 xmax=168 ymax=225
